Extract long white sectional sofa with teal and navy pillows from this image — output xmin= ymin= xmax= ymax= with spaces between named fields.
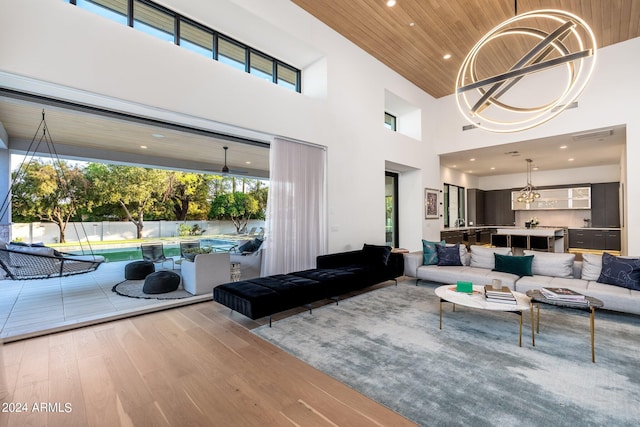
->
xmin=404 ymin=246 xmax=640 ymax=314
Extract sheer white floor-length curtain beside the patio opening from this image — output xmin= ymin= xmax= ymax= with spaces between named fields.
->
xmin=262 ymin=138 xmax=327 ymax=276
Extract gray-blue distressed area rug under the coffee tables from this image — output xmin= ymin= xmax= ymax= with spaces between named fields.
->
xmin=254 ymin=282 xmax=640 ymax=426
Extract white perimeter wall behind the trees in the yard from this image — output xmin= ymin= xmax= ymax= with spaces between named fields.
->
xmin=11 ymin=220 xmax=264 ymax=244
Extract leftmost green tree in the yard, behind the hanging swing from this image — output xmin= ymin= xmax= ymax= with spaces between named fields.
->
xmin=11 ymin=160 xmax=88 ymax=243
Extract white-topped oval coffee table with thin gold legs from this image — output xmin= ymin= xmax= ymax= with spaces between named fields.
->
xmin=435 ymin=285 xmax=536 ymax=347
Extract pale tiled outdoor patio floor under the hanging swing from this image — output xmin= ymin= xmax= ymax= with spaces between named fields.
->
xmin=0 ymin=261 xmax=212 ymax=342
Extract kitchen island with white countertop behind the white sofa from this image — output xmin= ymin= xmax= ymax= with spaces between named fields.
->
xmin=491 ymin=227 xmax=566 ymax=252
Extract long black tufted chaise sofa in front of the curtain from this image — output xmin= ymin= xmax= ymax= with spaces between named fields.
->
xmin=213 ymin=244 xmax=404 ymax=325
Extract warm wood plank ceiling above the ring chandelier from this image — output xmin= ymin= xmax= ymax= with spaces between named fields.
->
xmin=292 ymin=0 xmax=640 ymax=98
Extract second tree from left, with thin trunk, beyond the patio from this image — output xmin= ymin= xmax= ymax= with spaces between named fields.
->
xmin=87 ymin=163 xmax=166 ymax=239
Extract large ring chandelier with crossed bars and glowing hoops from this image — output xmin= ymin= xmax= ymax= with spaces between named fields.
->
xmin=456 ymin=7 xmax=597 ymax=132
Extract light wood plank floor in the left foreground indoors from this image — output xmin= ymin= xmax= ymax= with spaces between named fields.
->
xmin=0 ymin=302 xmax=413 ymax=427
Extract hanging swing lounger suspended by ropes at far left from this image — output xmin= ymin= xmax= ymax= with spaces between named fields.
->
xmin=0 ymin=245 xmax=104 ymax=280
